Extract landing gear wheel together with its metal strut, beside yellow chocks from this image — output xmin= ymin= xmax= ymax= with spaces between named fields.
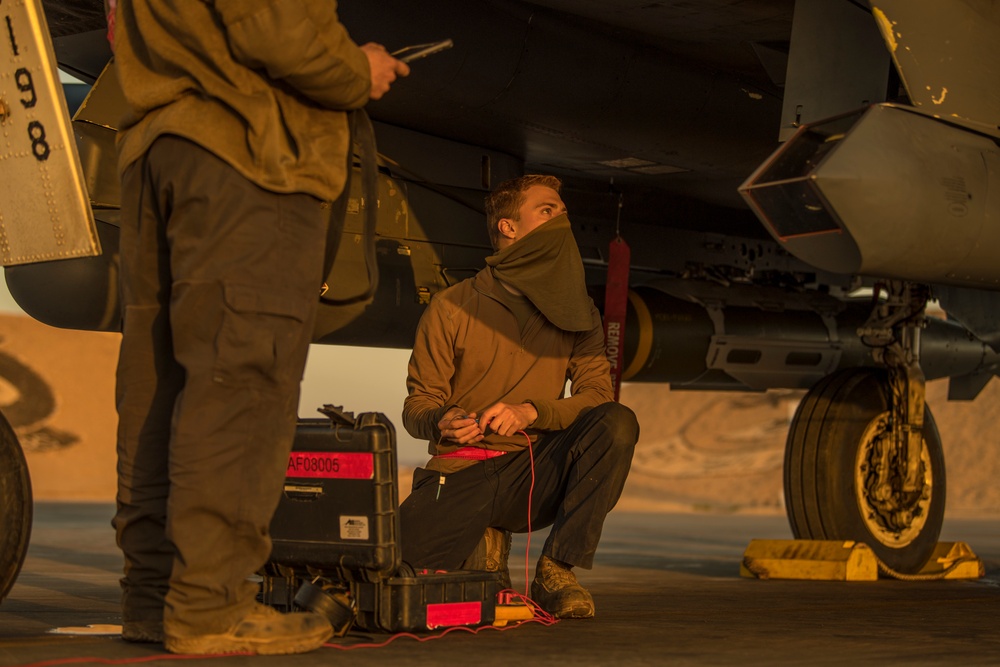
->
xmin=785 ymin=282 xmax=946 ymax=573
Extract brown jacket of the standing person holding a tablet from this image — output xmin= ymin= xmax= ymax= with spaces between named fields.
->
xmin=115 ymin=0 xmax=370 ymax=200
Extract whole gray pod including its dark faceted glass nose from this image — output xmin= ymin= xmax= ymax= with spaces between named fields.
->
xmin=740 ymin=104 xmax=1000 ymax=289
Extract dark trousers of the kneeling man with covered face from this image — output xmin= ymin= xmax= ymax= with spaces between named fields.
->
xmin=399 ymin=403 xmax=639 ymax=570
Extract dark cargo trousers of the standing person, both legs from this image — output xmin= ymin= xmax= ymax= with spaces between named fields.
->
xmin=113 ymin=136 xmax=330 ymax=636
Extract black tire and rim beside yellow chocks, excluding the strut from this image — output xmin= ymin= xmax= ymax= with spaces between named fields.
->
xmin=785 ymin=369 xmax=947 ymax=574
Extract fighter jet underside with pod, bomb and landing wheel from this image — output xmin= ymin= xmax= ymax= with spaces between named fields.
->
xmin=0 ymin=0 xmax=1000 ymax=592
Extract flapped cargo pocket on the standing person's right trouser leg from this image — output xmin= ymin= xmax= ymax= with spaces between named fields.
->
xmin=214 ymin=284 xmax=311 ymax=385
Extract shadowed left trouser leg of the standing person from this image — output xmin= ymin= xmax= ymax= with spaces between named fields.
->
xmin=112 ymin=144 xmax=184 ymax=641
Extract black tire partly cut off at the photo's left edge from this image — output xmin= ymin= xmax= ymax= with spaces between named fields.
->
xmin=0 ymin=415 xmax=31 ymax=600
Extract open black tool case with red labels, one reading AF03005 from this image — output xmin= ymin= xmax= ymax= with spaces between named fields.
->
xmin=261 ymin=405 xmax=500 ymax=632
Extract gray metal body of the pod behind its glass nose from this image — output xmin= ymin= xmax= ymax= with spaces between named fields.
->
xmin=815 ymin=105 xmax=1000 ymax=289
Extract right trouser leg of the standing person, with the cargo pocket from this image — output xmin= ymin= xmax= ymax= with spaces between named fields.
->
xmin=116 ymin=137 xmax=329 ymax=650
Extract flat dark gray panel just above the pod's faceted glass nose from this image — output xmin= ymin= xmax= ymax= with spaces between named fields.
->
xmin=779 ymin=0 xmax=889 ymax=141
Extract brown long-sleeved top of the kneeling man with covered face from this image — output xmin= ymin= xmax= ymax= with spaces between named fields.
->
xmin=403 ymin=267 xmax=614 ymax=469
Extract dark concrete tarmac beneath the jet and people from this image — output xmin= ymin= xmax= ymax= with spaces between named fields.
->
xmin=0 ymin=503 xmax=1000 ymax=667
